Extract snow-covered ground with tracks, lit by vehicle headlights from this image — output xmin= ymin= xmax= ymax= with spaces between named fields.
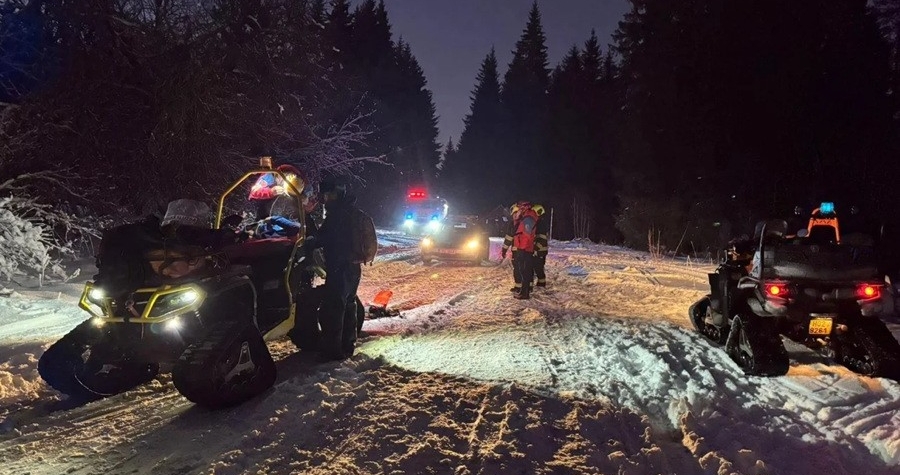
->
xmin=0 ymin=233 xmax=900 ymax=475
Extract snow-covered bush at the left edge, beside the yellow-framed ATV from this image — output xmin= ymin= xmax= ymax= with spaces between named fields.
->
xmin=0 ymin=196 xmax=70 ymax=283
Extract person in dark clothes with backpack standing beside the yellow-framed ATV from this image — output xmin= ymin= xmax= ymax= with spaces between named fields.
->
xmin=313 ymin=181 xmax=361 ymax=361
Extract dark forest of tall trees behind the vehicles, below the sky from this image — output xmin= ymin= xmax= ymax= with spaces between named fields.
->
xmin=0 ymin=0 xmax=900 ymax=253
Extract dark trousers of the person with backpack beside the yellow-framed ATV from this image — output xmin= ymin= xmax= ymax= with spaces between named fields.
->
xmin=319 ymin=263 xmax=361 ymax=357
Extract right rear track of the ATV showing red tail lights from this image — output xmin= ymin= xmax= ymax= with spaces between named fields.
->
xmin=835 ymin=317 xmax=900 ymax=379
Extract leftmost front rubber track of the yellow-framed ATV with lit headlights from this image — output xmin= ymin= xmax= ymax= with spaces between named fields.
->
xmin=38 ymin=320 xmax=159 ymax=401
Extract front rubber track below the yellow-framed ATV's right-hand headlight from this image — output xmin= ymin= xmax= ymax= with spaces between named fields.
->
xmin=172 ymin=323 xmax=276 ymax=409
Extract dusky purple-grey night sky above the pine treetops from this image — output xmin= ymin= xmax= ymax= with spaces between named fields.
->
xmin=376 ymin=0 xmax=628 ymax=149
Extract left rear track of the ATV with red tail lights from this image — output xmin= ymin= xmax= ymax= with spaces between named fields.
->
xmin=725 ymin=315 xmax=790 ymax=376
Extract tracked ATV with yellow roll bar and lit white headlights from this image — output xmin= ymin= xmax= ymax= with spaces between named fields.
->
xmin=38 ymin=159 xmax=312 ymax=408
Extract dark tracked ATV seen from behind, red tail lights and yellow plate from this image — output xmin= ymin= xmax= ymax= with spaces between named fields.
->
xmin=689 ymin=203 xmax=900 ymax=379
